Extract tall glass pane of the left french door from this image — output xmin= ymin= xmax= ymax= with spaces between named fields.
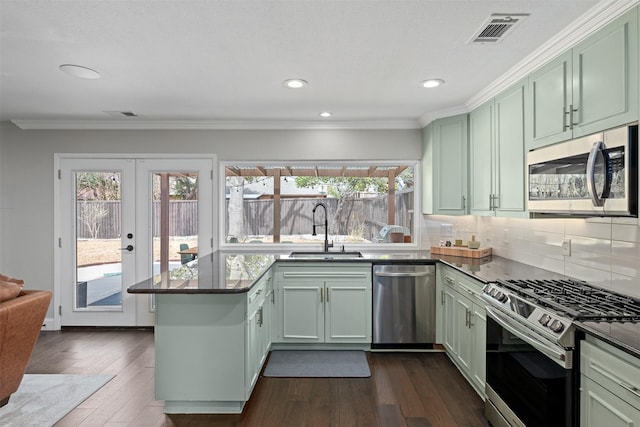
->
xmin=74 ymin=171 xmax=123 ymax=311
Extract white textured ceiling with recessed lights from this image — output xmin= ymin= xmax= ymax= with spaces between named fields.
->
xmin=0 ymin=0 xmax=629 ymax=127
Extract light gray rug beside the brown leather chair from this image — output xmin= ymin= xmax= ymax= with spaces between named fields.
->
xmin=0 ymin=374 xmax=113 ymax=427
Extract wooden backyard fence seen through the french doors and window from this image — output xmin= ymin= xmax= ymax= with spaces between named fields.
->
xmin=76 ymin=190 xmax=413 ymax=239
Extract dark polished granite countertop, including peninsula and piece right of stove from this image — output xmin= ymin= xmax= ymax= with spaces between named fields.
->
xmin=128 ymin=247 xmax=640 ymax=357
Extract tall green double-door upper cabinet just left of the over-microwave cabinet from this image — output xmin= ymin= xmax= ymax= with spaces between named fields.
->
xmin=469 ymin=82 xmax=527 ymax=216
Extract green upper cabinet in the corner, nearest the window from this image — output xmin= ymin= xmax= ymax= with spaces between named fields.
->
xmin=422 ymin=114 xmax=468 ymax=215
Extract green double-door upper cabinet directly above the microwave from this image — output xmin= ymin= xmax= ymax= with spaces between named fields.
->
xmin=528 ymin=8 xmax=639 ymax=149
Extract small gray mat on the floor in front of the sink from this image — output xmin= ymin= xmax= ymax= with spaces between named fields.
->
xmin=263 ymin=350 xmax=371 ymax=378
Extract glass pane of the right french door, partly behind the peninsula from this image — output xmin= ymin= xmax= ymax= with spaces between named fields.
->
xmin=152 ymin=172 xmax=198 ymax=281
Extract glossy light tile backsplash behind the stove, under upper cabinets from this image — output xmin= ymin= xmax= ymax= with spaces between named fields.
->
xmin=420 ymin=215 xmax=640 ymax=297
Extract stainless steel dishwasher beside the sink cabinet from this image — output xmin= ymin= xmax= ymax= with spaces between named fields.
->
xmin=371 ymin=264 xmax=436 ymax=349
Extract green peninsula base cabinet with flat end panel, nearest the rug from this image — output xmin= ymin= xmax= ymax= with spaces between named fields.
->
xmin=154 ymin=271 xmax=273 ymax=414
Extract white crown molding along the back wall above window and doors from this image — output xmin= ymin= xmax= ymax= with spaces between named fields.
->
xmin=11 ymin=119 xmax=421 ymax=130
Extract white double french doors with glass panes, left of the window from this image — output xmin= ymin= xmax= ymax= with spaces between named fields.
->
xmin=54 ymin=156 xmax=215 ymax=326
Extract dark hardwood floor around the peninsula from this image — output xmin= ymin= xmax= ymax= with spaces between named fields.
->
xmin=27 ymin=329 xmax=487 ymax=427
